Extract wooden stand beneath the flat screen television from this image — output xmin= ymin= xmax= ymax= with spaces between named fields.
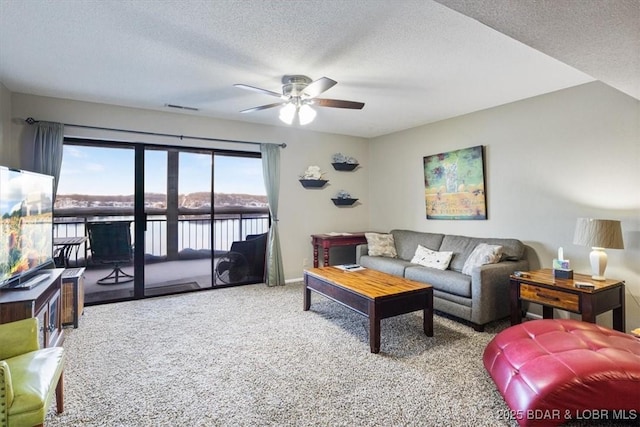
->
xmin=0 ymin=268 xmax=64 ymax=348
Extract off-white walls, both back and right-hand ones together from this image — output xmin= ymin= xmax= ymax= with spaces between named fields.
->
xmin=6 ymin=83 xmax=640 ymax=329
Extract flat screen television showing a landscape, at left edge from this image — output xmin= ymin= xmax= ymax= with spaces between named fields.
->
xmin=0 ymin=166 xmax=53 ymax=288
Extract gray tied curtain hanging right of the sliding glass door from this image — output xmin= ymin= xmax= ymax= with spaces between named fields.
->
xmin=260 ymin=144 xmax=284 ymax=286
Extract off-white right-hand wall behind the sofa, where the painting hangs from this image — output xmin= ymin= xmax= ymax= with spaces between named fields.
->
xmin=367 ymin=82 xmax=640 ymax=330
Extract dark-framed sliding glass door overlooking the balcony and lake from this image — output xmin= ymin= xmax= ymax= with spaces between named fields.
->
xmin=54 ymin=139 xmax=269 ymax=304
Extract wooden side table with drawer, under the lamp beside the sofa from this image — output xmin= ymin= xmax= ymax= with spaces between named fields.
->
xmin=510 ymin=269 xmax=625 ymax=332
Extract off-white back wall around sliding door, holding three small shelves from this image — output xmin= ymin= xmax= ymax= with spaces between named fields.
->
xmin=5 ymin=93 xmax=369 ymax=280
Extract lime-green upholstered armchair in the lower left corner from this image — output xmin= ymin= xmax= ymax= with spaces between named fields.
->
xmin=0 ymin=318 xmax=64 ymax=427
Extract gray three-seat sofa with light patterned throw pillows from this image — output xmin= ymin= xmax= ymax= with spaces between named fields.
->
xmin=356 ymin=230 xmax=529 ymax=331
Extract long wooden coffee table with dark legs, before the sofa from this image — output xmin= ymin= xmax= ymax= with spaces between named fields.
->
xmin=303 ymin=267 xmax=433 ymax=353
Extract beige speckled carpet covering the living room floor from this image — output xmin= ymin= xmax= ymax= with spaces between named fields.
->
xmin=46 ymin=284 xmax=628 ymax=427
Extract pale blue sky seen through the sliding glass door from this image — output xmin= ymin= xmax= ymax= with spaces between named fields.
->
xmin=58 ymin=145 xmax=266 ymax=195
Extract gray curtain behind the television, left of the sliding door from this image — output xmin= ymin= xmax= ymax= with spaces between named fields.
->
xmin=22 ymin=122 xmax=64 ymax=199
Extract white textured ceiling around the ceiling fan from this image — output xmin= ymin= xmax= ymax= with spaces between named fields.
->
xmin=0 ymin=0 xmax=640 ymax=137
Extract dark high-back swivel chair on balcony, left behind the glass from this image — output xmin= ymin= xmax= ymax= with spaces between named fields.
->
xmin=87 ymin=221 xmax=133 ymax=285
